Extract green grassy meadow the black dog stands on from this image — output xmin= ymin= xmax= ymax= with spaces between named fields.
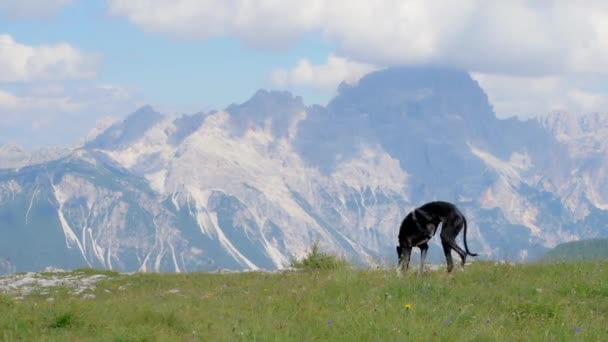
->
xmin=0 ymin=262 xmax=608 ymax=341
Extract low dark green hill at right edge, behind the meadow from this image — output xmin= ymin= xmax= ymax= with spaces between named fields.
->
xmin=542 ymin=239 xmax=608 ymax=260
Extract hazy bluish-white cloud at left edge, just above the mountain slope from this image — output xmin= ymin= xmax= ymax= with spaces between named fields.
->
xmin=0 ymin=84 xmax=142 ymax=147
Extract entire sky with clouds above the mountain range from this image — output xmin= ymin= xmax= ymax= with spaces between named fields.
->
xmin=0 ymin=0 xmax=608 ymax=148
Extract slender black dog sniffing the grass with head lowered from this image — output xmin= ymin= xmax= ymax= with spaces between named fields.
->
xmin=397 ymin=201 xmax=477 ymax=274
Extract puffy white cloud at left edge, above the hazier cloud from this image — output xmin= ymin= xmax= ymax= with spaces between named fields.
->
xmin=0 ymin=34 xmax=99 ymax=82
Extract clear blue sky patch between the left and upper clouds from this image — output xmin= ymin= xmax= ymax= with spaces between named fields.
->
xmin=0 ymin=1 xmax=333 ymax=111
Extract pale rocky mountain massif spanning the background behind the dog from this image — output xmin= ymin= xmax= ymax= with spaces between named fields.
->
xmin=0 ymin=68 xmax=608 ymax=272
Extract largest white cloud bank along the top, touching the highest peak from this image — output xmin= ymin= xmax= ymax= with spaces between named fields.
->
xmin=108 ymin=0 xmax=608 ymax=76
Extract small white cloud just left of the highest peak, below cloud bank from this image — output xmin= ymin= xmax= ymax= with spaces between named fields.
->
xmin=272 ymin=54 xmax=378 ymax=91
